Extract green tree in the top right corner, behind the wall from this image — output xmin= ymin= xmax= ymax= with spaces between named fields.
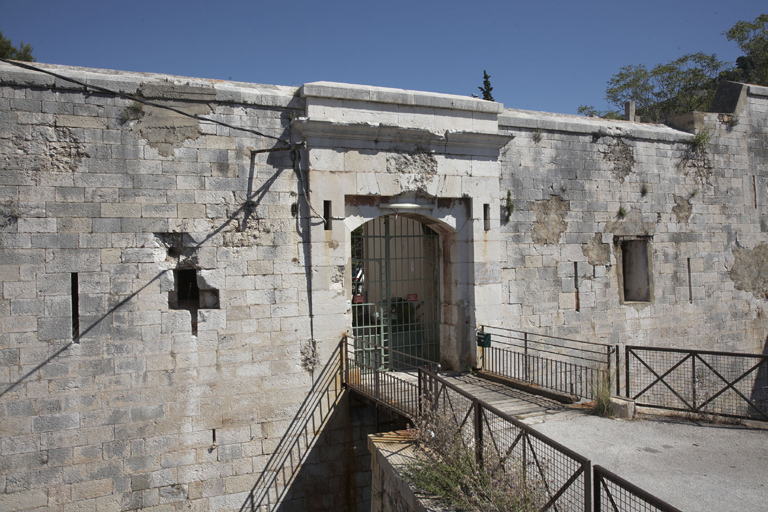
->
xmin=723 ymin=14 xmax=768 ymax=85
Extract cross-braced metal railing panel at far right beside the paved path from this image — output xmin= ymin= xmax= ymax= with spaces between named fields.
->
xmin=625 ymin=346 xmax=768 ymax=421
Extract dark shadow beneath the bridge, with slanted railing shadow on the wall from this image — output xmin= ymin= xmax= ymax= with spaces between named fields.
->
xmin=240 ymin=346 xmax=407 ymax=512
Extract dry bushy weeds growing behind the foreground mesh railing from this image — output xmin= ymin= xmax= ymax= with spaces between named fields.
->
xmin=405 ymin=396 xmax=546 ymax=512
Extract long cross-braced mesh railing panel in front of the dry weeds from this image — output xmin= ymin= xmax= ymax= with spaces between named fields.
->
xmin=419 ymin=368 xmax=592 ymax=512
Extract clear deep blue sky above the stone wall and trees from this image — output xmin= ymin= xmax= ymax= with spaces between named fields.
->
xmin=0 ymin=0 xmax=768 ymax=114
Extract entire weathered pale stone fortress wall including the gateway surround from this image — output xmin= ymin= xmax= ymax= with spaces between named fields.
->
xmin=0 ymin=64 xmax=768 ymax=510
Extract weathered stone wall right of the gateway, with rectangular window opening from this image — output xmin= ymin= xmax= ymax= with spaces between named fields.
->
xmin=499 ymin=86 xmax=768 ymax=352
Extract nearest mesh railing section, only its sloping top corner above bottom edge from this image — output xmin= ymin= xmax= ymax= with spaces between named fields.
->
xmin=592 ymin=465 xmax=681 ymax=512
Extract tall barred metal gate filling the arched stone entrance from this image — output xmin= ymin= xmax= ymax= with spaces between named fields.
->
xmin=352 ymin=215 xmax=440 ymax=370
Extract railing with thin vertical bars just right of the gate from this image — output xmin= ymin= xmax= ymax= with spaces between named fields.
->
xmin=478 ymin=326 xmax=619 ymax=399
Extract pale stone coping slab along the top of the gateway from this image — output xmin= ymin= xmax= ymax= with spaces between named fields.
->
xmin=299 ymin=82 xmax=504 ymax=114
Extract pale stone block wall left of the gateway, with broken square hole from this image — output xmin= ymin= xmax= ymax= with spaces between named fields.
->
xmin=0 ymin=64 xmax=340 ymax=510
